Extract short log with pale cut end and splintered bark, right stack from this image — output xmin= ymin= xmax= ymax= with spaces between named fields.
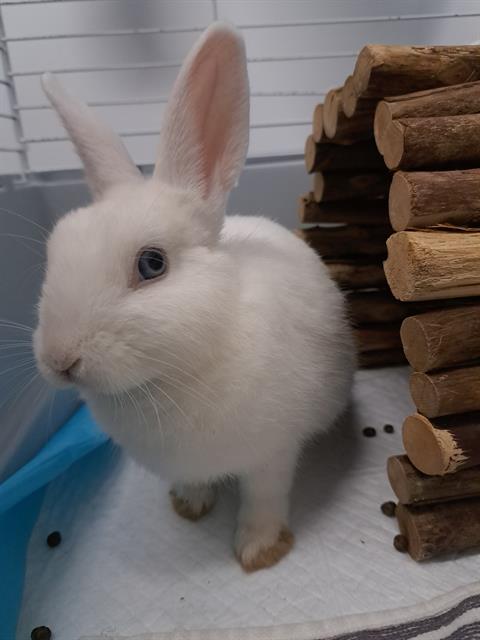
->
xmin=402 ymin=412 xmax=480 ymax=476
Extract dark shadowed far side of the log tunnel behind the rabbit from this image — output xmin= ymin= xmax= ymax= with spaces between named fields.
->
xmin=297 ymin=94 xmax=406 ymax=366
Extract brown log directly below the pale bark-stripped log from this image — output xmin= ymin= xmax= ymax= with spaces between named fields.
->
xmin=400 ymin=305 xmax=480 ymax=373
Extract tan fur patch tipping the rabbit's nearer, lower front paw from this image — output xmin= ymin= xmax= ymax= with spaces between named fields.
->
xmin=236 ymin=527 xmax=294 ymax=573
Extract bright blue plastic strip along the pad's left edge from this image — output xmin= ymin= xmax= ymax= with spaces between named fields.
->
xmin=0 ymin=406 xmax=108 ymax=640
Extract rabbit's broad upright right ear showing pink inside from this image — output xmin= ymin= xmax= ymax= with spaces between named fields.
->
xmin=154 ymin=23 xmax=249 ymax=201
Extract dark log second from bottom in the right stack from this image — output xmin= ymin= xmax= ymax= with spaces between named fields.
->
xmin=387 ymin=455 xmax=480 ymax=505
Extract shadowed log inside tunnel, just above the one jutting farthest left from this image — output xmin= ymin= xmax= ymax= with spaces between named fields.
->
xmin=313 ymin=171 xmax=390 ymax=202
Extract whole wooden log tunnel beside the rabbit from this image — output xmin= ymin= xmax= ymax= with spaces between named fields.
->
xmin=300 ymin=45 xmax=480 ymax=560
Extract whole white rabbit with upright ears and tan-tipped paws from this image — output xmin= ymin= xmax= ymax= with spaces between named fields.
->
xmin=34 ymin=24 xmax=355 ymax=571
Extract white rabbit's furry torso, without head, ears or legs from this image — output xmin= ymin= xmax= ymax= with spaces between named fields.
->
xmin=86 ymin=216 xmax=354 ymax=483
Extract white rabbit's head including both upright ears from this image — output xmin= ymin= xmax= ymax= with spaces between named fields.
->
xmin=34 ymin=24 xmax=249 ymax=393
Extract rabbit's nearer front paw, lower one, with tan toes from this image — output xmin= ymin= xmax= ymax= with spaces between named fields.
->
xmin=235 ymin=525 xmax=294 ymax=573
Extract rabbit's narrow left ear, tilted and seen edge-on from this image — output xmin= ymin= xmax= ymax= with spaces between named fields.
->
xmin=42 ymin=73 xmax=141 ymax=199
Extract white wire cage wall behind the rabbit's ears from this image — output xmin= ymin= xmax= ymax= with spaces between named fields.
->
xmin=0 ymin=0 xmax=480 ymax=177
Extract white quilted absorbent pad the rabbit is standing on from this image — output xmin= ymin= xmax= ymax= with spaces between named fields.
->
xmin=18 ymin=368 xmax=480 ymax=640
